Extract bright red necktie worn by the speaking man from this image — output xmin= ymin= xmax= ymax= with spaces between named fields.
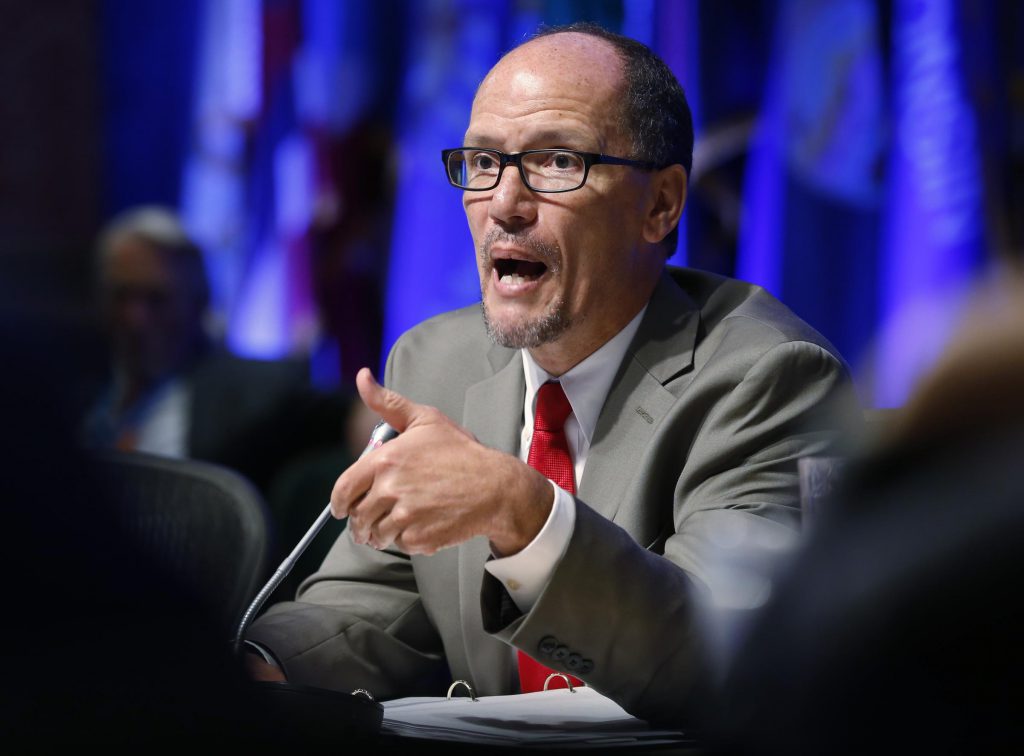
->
xmin=519 ymin=382 xmax=583 ymax=692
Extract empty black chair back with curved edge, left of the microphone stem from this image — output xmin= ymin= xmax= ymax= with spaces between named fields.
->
xmin=96 ymin=452 xmax=269 ymax=639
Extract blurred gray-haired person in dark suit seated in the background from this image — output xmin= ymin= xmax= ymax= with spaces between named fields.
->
xmin=84 ymin=207 xmax=348 ymax=491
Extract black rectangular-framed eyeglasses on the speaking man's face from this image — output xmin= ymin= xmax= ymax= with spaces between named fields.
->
xmin=441 ymin=148 xmax=657 ymax=193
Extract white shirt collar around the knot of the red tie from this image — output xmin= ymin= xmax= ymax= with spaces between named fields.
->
xmin=521 ymin=304 xmax=647 ymax=444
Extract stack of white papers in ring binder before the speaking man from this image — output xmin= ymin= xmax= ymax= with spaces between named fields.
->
xmin=381 ymin=687 xmax=692 ymax=748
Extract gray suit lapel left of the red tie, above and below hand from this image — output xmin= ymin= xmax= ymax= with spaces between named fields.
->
xmin=459 ymin=347 xmax=526 ymax=691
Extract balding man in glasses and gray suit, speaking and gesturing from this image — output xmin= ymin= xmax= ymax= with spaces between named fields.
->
xmin=249 ymin=26 xmax=852 ymax=721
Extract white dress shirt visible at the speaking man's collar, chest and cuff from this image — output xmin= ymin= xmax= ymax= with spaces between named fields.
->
xmin=484 ymin=305 xmax=647 ymax=614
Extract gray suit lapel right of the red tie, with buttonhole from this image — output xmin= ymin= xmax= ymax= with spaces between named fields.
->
xmin=579 ymin=274 xmax=700 ymax=520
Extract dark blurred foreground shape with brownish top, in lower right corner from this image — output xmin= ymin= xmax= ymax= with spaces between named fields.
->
xmin=716 ymin=278 xmax=1024 ymax=754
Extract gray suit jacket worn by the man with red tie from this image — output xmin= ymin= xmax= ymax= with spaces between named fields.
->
xmin=250 ymin=269 xmax=856 ymax=720
